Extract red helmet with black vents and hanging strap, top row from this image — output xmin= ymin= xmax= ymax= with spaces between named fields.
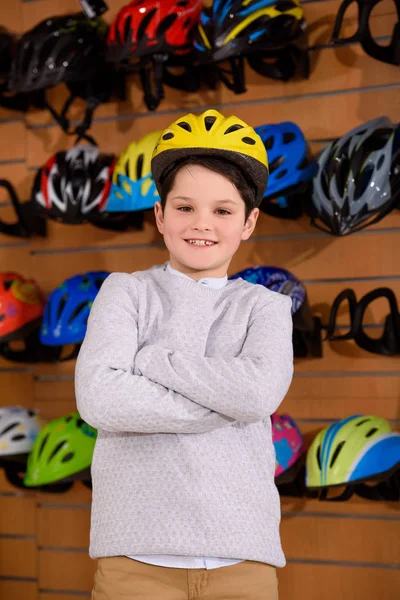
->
xmin=107 ymin=0 xmax=202 ymax=110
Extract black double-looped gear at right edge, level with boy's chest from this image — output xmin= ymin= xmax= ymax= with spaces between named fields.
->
xmin=326 ymin=288 xmax=400 ymax=356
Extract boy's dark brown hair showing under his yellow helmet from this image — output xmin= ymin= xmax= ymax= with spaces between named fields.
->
xmin=156 ymin=156 xmax=259 ymax=222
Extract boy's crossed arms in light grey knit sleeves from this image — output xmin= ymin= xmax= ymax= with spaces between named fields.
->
xmin=75 ymin=273 xmax=293 ymax=433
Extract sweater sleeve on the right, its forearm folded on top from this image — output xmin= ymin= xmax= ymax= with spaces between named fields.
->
xmin=136 ymin=294 xmax=293 ymax=422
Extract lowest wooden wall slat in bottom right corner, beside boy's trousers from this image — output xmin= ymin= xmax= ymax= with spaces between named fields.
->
xmin=278 ymin=564 xmax=400 ymax=600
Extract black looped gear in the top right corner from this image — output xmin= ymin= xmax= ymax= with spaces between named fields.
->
xmin=332 ymin=0 xmax=400 ymax=65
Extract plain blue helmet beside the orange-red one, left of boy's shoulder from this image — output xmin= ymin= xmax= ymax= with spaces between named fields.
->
xmin=40 ymin=271 xmax=109 ymax=344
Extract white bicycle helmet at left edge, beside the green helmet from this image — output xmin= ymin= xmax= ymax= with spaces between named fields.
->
xmin=0 ymin=406 xmax=44 ymax=459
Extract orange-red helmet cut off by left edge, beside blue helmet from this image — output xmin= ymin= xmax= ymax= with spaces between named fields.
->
xmin=0 ymin=272 xmax=46 ymax=343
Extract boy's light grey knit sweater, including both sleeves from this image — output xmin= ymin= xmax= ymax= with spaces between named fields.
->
xmin=75 ymin=265 xmax=293 ymax=566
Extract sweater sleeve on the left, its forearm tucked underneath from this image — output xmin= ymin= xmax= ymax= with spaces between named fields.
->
xmin=75 ymin=273 xmax=234 ymax=433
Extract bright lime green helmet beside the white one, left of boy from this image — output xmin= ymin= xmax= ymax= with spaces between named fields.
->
xmin=24 ymin=411 xmax=97 ymax=487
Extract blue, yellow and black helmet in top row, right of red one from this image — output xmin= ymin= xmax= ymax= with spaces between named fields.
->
xmin=194 ymin=0 xmax=308 ymax=94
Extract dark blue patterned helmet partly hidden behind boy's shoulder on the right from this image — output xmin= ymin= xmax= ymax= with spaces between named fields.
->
xmin=230 ymin=267 xmax=306 ymax=316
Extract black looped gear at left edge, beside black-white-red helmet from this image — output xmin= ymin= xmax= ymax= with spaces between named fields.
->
xmin=0 ymin=179 xmax=46 ymax=238
